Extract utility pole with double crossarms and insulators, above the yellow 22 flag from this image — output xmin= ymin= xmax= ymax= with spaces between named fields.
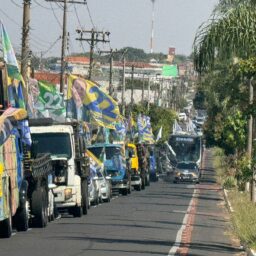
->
xmin=76 ymin=29 xmax=110 ymax=79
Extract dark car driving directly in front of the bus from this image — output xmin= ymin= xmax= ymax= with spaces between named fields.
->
xmin=173 ymin=162 xmax=201 ymax=183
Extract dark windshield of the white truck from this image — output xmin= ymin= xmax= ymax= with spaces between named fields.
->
xmin=31 ymin=133 xmax=72 ymax=159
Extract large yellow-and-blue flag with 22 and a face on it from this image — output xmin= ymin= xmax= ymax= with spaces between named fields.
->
xmin=67 ymin=75 xmax=120 ymax=129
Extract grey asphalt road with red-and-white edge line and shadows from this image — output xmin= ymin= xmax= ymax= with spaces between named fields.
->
xmin=0 ymin=149 xmax=244 ymax=256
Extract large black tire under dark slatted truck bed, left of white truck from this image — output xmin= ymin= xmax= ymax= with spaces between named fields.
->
xmin=31 ymin=187 xmax=48 ymax=228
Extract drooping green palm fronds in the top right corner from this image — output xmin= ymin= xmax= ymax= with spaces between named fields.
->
xmin=194 ymin=0 xmax=256 ymax=72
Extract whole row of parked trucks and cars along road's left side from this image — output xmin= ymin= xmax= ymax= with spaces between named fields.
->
xmin=0 ymin=112 xmax=158 ymax=238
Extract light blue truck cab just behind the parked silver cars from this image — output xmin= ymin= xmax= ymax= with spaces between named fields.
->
xmin=88 ymin=143 xmax=131 ymax=195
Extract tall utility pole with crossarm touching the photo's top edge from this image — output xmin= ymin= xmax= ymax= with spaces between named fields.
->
xmin=45 ymin=0 xmax=86 ymax=93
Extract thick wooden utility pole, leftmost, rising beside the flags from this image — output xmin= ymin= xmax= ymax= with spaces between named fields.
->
xmin=21 ymin=0 xmax=31 ymax=102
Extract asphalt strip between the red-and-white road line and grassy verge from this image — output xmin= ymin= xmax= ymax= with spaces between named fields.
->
xmin=187 ymin=150 xmax=246 ymax=256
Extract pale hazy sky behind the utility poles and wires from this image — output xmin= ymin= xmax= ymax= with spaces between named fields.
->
xmin=0 ymin=0 xmax=218 ymax=56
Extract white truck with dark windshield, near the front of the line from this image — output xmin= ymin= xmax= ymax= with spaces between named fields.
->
xmin=30 ymin=119 xmax=89 ymax=217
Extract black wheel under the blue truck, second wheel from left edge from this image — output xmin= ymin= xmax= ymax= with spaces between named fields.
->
xmin=14 ymin=201 xmax=29 ymax=231
